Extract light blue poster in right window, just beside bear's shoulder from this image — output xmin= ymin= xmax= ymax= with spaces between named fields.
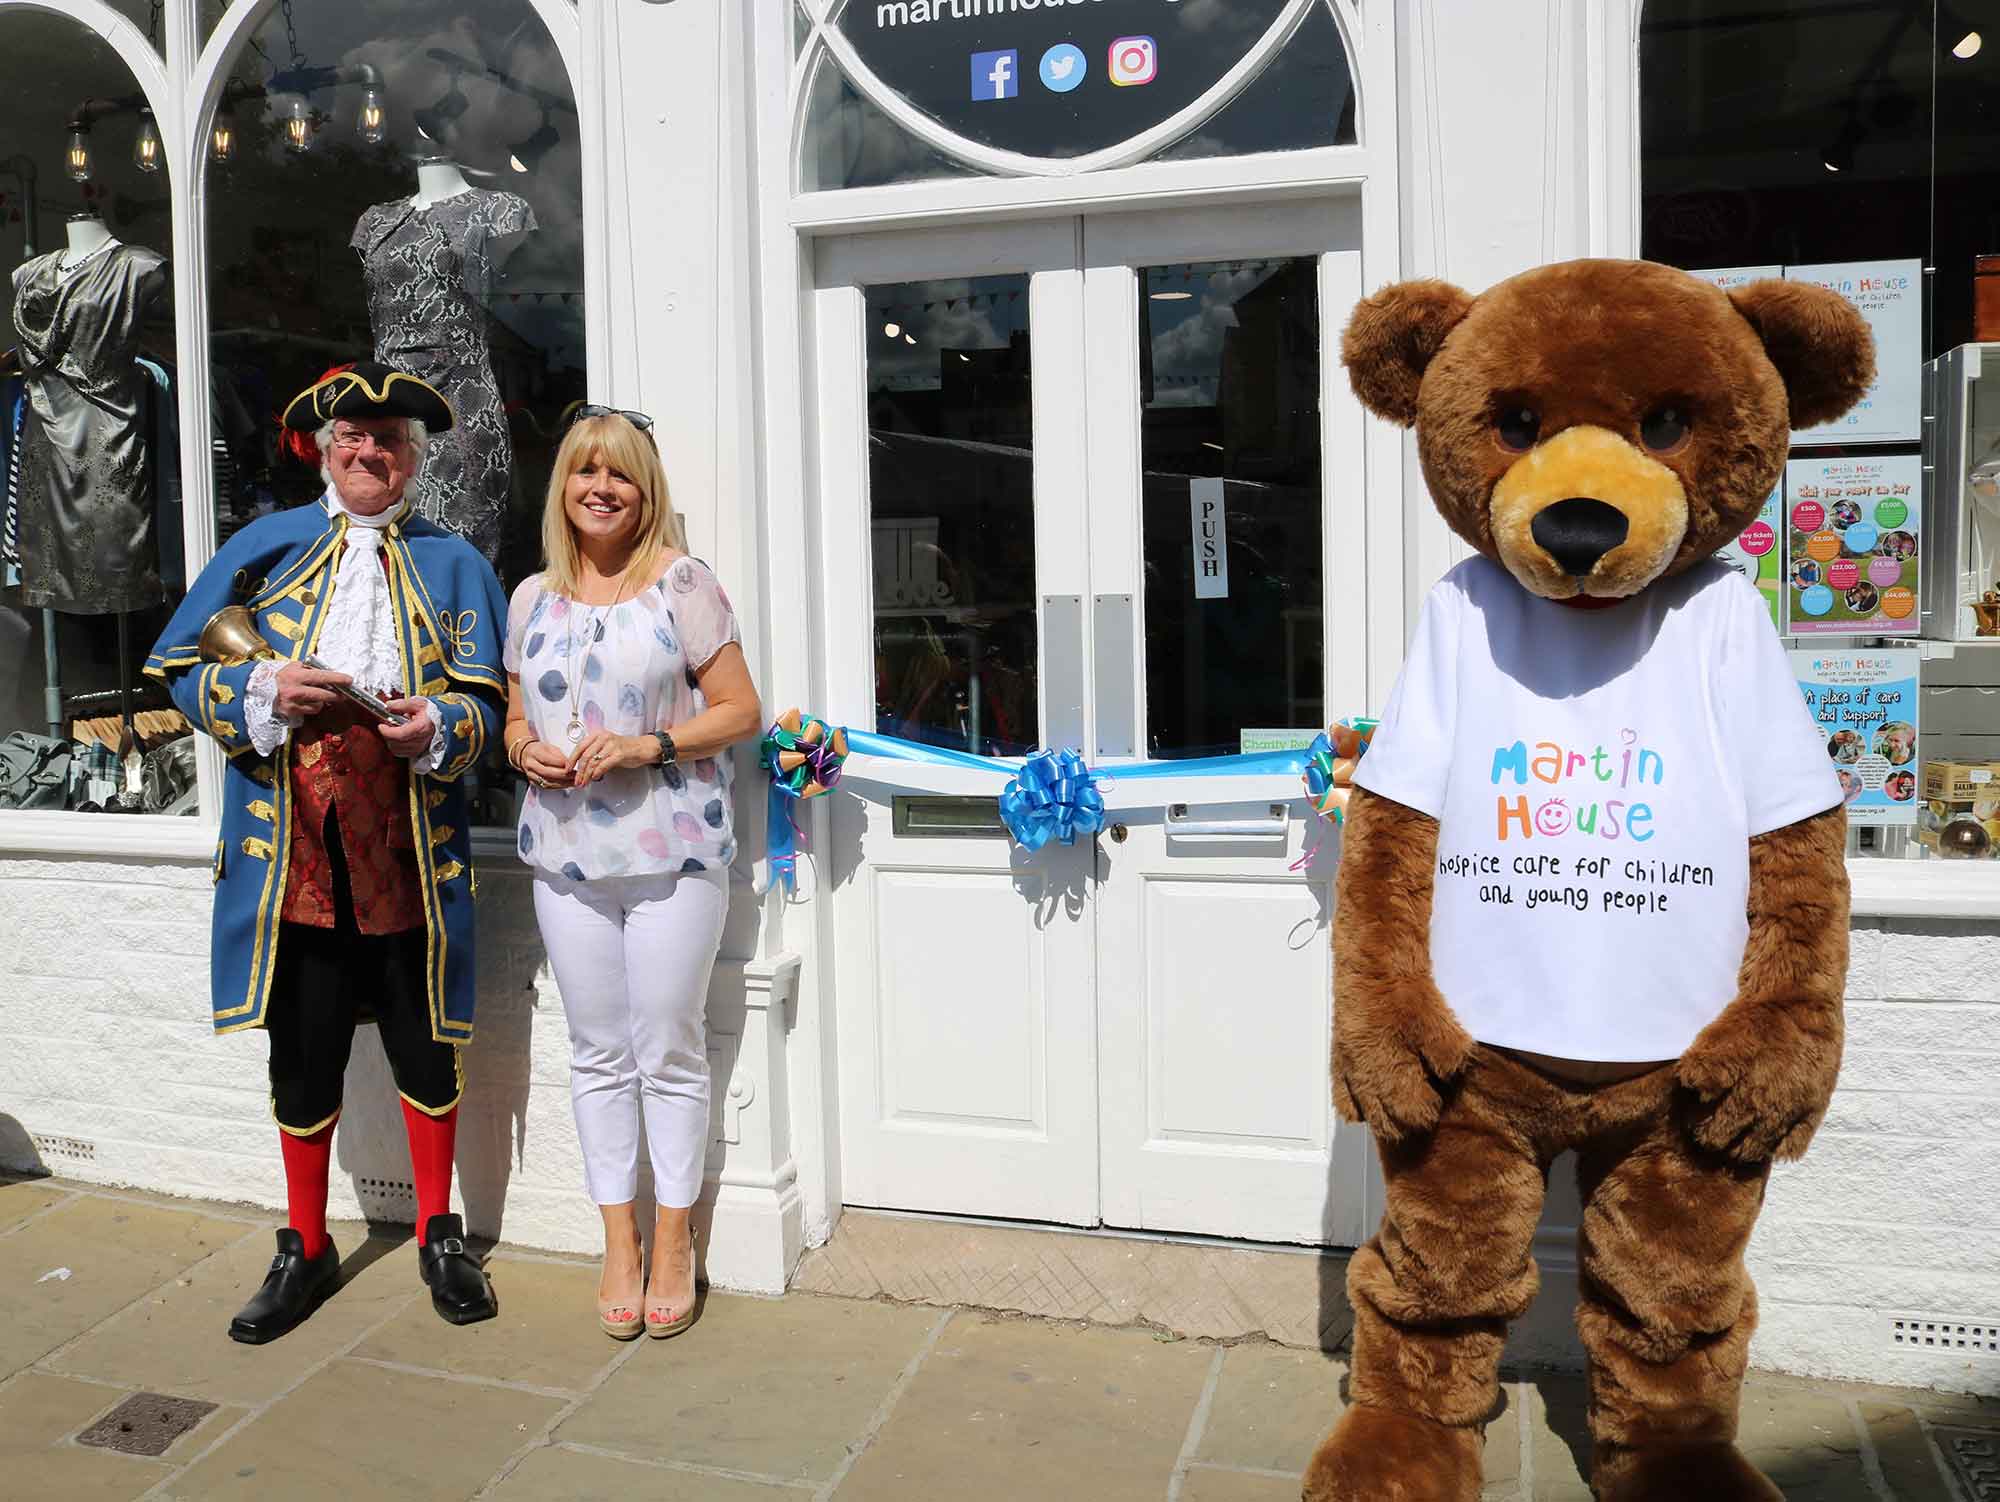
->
xmin=1792 ymin=648 xmax=1922 ymax=826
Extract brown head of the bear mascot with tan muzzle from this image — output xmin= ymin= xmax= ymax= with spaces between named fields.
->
xmin=1342 ymin=260 xmax=1874 ymax=600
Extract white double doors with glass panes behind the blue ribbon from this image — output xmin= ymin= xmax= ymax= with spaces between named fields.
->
xmin=812 ymin=202 xmax=1366 ymax=1244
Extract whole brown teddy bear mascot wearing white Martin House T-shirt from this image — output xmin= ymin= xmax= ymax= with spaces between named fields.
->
xmin=1304 ymin=260 xmax=1874 ymax=1502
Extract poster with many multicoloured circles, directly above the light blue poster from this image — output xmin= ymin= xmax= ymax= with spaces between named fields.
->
xmin=1784 ymin=454 xmax=1924 ymax=636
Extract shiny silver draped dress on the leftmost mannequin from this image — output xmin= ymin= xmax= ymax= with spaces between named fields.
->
xmin=14 ymin=240 xmax=168 ymax=616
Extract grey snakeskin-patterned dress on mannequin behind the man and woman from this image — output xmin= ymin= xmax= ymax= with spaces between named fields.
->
xmin=352 ymin=188 xmax=536 ymax=562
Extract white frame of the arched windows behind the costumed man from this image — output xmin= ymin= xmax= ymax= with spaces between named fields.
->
xmin=0 ymin=0 xmax=592 ymax=860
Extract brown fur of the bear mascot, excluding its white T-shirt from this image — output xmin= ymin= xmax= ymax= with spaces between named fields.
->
xmin=1306 ymin=262 xmax=1872 ymax=1502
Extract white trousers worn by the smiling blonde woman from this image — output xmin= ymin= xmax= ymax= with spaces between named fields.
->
xmin=534 ymin=870 xmax=728 ymax=1210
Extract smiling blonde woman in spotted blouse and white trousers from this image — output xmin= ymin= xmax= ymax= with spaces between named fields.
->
xmin=506 ymin=406 xmax=764 ymax=1340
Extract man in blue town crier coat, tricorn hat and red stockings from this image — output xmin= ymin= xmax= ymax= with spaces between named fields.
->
xmin=146 ymin=362 xmax=506 ymax=1344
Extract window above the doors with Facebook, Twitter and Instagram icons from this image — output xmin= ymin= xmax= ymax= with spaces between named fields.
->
xmin=794 ymin=0 xmax=1356 ymax=192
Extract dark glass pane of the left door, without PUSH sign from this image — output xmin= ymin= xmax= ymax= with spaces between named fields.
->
xmin=868 ymin=276 xmax=1040 ymax=756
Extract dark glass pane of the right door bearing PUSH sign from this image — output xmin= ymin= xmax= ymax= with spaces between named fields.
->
xmin=1138 ymin=256 xmax=1326 ymax=756
